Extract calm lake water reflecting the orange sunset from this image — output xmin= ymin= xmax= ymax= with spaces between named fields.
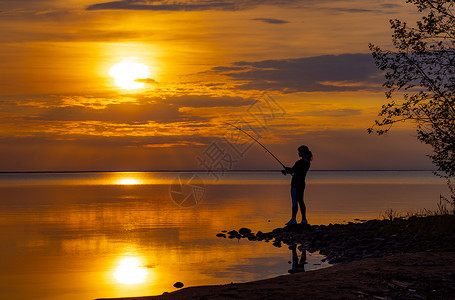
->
xmin=0 ymin=171 xmax=447 ymax=300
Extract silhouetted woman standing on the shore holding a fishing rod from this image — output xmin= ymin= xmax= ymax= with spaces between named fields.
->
xmin=282 ymin=145 xmax=313 ymax=225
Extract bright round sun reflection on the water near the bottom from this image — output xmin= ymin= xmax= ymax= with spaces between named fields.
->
xmin=114 ymin=257 xmax=148 ymax=284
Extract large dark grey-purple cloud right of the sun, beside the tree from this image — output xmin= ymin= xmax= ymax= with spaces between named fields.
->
xmin=211 ymin=54 xmax=383 ymax=93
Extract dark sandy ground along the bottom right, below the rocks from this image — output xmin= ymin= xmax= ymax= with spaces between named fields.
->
xmin=98 ymin=252 xmax=455 ymax=300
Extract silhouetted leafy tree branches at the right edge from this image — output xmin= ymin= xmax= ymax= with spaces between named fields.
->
xmin=368 ymin=0 xmax=455 ymax=210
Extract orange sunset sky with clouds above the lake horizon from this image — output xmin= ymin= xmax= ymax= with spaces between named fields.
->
xmin=0 ymin=0 xmax=433 ymax=171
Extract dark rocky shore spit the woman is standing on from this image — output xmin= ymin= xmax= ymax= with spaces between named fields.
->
xmin=217 ymin=215 xmax=455 ymax=264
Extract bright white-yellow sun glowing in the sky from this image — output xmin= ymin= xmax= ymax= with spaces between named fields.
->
xmin=109 ymin=62 xmax=150 ymax=90
